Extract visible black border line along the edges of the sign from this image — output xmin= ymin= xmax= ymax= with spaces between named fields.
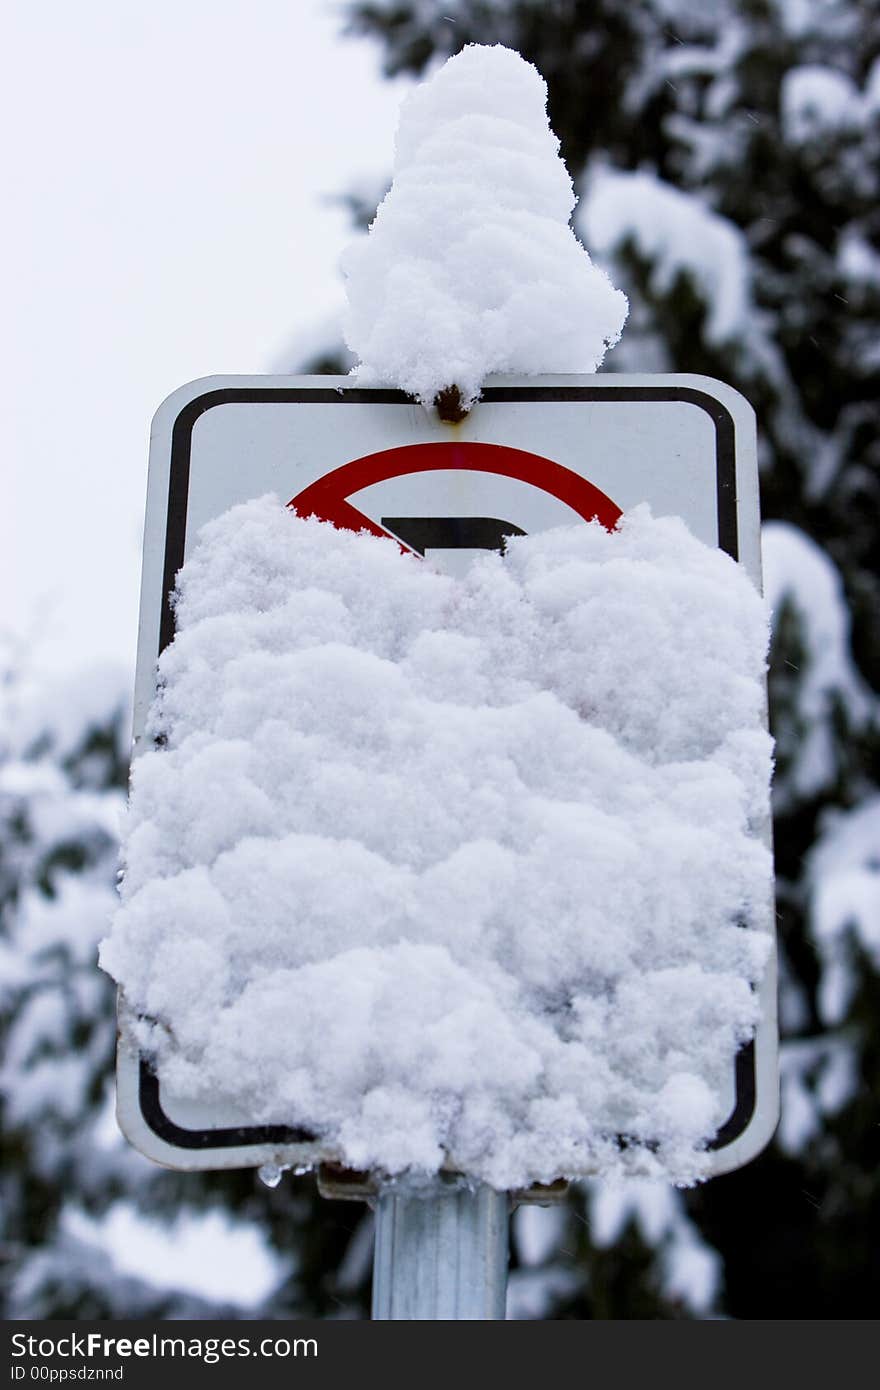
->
xmin=138 ymin=384 xmax=758 ymax=1151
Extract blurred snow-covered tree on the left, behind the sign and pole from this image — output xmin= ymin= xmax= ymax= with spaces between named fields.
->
xmin=0 ymin=660 xmax=368 ymax=1318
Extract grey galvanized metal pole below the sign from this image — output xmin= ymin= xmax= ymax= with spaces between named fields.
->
xmin=373 ymin=1183 xmax=510 ymax=1322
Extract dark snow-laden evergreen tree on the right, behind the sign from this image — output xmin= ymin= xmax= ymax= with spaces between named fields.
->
xmin=325 ymin=0 xmax=880 ymax=1318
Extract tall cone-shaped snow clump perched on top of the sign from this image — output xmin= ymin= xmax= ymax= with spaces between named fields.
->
xmin=336 ymin=44 xmax=627 ymax=404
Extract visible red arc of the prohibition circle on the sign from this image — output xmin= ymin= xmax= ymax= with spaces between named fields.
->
xmin=288 ymin=439 xmax=621 ymax=537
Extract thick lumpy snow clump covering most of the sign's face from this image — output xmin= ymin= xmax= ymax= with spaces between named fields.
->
xmin=101 ymin=498 xmax=770 ymax=1187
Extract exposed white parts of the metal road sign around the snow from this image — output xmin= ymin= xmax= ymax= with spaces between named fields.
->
xmin=118 ymin=375 xmax=777 ymax=1173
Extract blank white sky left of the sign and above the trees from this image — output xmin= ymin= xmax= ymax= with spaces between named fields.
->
xmin=0 ymin=0 xmax=403 ymax=670
